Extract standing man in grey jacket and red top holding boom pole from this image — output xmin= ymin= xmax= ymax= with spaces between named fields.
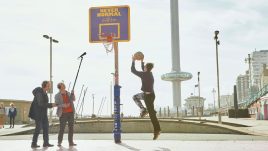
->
xmin=55 ymin=83 xmax=76 ymax=147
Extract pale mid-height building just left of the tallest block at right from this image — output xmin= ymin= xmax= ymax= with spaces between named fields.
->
xmin=236 ymin=74 xmax=249 ymax=103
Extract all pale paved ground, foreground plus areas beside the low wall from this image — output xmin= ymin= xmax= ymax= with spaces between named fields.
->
xmin=0 ymin=117 xmax=268 ymax=151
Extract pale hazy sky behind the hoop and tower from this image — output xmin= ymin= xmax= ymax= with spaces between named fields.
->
xmin=0 ymin=0 xmax=268 ymax=115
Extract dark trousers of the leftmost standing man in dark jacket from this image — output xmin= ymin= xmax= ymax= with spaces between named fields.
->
xmin=32 ymin=116 xmax=49 ymax=145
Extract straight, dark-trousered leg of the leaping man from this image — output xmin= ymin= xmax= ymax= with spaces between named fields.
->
xmin=144 ymin=93 xmax=161 ymax=131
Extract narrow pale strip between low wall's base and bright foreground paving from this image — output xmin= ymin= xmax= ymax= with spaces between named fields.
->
xmin=0 ymin=133 xmax=268 ymax=142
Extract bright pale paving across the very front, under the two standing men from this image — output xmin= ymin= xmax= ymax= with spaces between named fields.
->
xmin=0 ymin=140 xmax=268 ymax=151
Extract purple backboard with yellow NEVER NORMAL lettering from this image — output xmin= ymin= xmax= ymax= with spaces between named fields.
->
xmin=89 ymin=6 xmax=130 ymax=43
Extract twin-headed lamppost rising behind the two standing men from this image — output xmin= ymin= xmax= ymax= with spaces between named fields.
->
xmin=43 ymin=35 xmax=59 ymax=123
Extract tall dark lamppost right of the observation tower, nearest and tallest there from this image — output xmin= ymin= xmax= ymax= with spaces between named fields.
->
xmin=214 ymin=30 xmax=221 ymax=124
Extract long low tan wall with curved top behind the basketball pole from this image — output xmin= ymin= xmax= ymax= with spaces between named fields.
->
xmin=21 ymin=119 xmax=245 ymax=134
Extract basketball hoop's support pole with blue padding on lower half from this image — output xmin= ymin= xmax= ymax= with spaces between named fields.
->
xmin=113 ymin=42 xmax=121 ymax=143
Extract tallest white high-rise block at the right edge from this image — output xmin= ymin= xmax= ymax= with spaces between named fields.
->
xmin=251 ymin=50 xmax=268 ymax=89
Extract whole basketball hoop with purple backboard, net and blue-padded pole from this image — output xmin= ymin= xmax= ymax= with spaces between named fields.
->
xmin=89 ymin=5 xmax=130 ymax=143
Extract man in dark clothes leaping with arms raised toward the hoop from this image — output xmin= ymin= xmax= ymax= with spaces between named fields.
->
xmin=131 ymin=56 xmax=161 ymax=140
